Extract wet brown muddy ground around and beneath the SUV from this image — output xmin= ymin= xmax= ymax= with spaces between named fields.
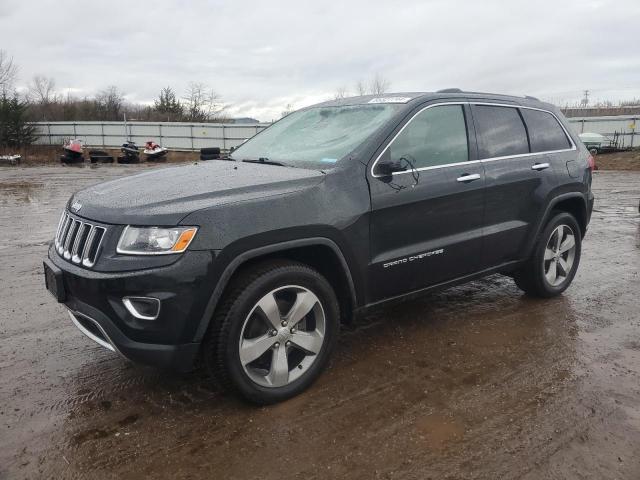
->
xmin=0 ymin=166 xmax=640 ymax=480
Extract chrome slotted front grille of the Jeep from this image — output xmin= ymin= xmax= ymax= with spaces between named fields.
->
xmin=55 ymin=211 xmax=106 ymax=268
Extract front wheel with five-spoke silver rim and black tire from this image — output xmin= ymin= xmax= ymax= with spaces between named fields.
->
xmin=204 ymin=261 xmax=340 ymax=404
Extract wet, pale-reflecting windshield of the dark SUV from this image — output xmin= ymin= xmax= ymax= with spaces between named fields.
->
xmin=231 ymin=104 xmax=400 ymax=168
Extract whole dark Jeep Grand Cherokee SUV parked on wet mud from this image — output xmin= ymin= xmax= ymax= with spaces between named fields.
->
xmin=44 ymin=89 xmax=593 ymax=403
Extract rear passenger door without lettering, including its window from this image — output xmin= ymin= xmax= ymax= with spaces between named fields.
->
xmin=472 ymin=103 xmax=557 ymax=268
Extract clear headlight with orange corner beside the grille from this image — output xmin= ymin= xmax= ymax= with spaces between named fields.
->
xmin=116 ymin=226 xmax=198 ymax=255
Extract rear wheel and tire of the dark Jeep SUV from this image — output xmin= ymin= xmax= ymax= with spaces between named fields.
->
xmin=513 ymin=212 xmax=582 ymax=298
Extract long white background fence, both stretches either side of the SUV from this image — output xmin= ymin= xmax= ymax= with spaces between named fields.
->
xmin=35 ymin=115 xmax=640 ymax=150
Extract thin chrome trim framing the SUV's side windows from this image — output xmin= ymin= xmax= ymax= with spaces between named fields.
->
xmin=370 ymin=100 xmax=577 ymax=178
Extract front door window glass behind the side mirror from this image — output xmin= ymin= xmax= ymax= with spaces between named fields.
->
xmin=389 ymin=105 xmax=469 ymax=168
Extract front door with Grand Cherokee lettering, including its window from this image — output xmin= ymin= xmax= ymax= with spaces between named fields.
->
xmin=369 ymin=103 xmax=484 ymax=302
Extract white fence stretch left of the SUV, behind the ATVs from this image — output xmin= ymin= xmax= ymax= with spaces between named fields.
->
xmin=35 ymin=122 xmax=269 ymax=150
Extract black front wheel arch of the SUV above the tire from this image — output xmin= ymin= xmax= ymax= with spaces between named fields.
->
xmin=194 ymin=237 xmax=358 ymax=342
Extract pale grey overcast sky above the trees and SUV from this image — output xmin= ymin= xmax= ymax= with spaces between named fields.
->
xmin=0 ymin=0 xmax=640 ymax=120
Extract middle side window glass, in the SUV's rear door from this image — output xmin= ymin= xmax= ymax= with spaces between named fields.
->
xmin=473 ymin=105 xmax=529 ymax=159
